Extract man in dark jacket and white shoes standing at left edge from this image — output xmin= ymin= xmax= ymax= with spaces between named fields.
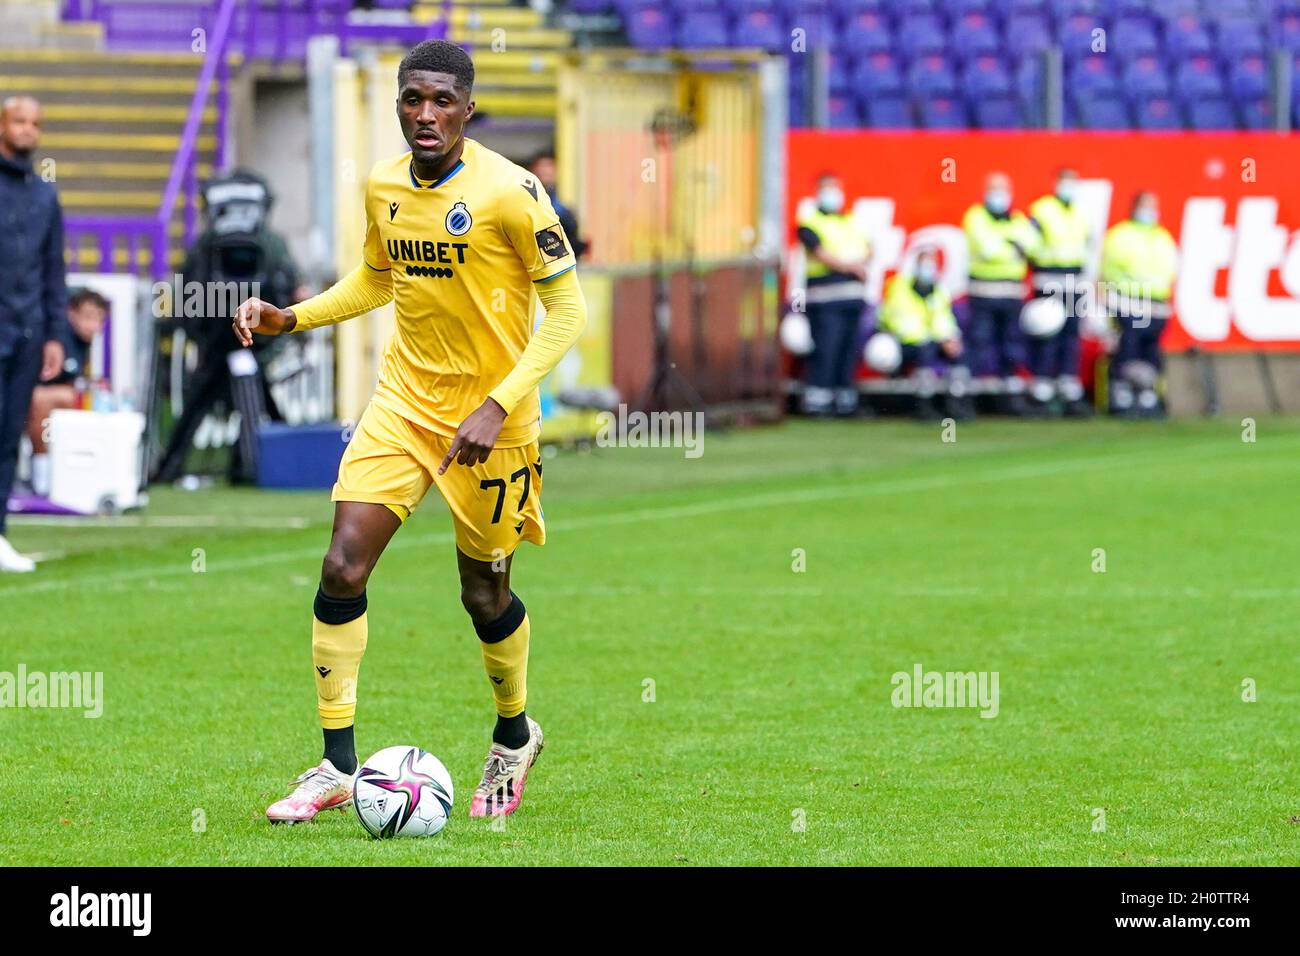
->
xmin=0 ymin=96 xmax=68 ymax=571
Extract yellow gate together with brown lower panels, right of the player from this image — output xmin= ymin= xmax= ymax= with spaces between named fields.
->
xmin=555 ymin=49 xmax=787 ymax=416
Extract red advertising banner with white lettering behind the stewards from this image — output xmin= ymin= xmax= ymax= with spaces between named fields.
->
xmin=788 ymin=130 xmax=1300 ymax=350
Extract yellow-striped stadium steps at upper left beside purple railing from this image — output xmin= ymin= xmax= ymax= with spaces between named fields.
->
xmin=0 ymin=47 xmax=220 ymax=268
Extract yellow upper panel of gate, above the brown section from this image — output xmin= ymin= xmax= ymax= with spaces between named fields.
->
xmin=556 ymin=52 xmax=762 ymax=265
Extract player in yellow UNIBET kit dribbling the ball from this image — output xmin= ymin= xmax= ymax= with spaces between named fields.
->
xmin=233 ymin=40 xmax=586 ymax=822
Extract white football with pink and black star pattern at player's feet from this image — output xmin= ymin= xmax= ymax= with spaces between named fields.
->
xmin=352 ymin=747 xmax=454 ymax=840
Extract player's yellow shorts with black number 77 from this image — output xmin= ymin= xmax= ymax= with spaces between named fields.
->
xmin=330 ymin=402 xmax=546 ymax=561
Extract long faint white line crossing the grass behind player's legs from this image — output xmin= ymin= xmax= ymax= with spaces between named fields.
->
xmin=0 ymin=434 xmax=1279 ymax=596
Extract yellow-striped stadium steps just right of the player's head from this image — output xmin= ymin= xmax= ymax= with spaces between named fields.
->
xmin=411 ymin=0 xmax=573 ymax=120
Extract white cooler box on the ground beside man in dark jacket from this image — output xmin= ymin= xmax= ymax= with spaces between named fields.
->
xmin=49 ymin=408 xmax=144 ymax=515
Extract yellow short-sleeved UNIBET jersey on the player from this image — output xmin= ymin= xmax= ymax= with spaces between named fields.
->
xmin=351 ymin=138 xmax=576 ymax=447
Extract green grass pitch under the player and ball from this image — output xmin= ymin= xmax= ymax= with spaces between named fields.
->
xmin=0 ymin=419 xmax=1300 ymax=866
